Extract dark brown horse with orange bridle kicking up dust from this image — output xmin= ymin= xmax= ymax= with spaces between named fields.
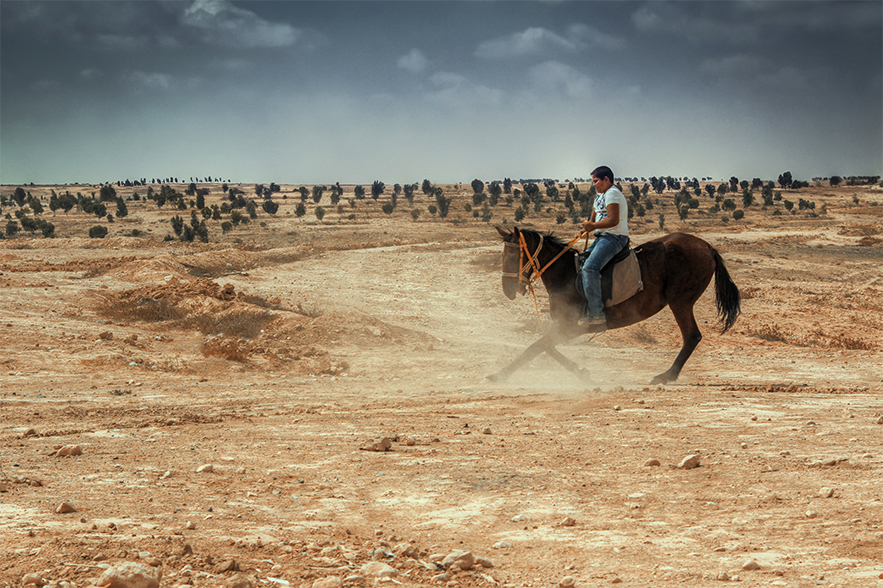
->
xmin=488 ymin=227 xmax=741 ymax=384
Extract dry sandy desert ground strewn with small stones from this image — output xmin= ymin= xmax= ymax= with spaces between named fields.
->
xmin=0 ymin=182 xmax=883 ymax=588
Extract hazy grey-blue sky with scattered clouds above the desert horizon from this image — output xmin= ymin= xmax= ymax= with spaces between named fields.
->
xmin=0 ymin=0 xmax=883 ymax=184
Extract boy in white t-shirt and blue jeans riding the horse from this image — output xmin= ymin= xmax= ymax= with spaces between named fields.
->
xmin=579 ymin=165 xmax=629 ymax=326
